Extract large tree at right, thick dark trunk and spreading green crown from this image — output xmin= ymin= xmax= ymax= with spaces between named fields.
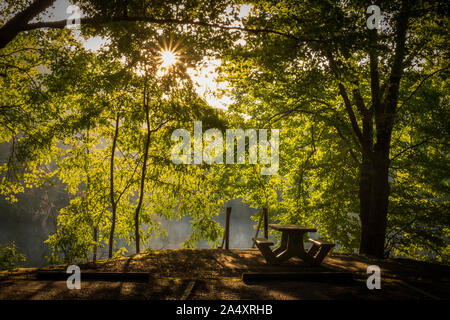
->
xmin=225 ymin=1 xmax=448 ymax=258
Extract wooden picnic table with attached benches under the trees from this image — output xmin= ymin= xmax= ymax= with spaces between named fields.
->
xmin=254 ymin=224 xmax=334 ymax=265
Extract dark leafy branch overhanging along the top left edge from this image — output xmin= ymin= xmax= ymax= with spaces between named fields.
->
xmin=0 ymin=0 xmax=242 ymax=49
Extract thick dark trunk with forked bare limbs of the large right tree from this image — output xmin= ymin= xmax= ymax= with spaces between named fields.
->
xmin=326 ymin=1 xmax=411 ymax=258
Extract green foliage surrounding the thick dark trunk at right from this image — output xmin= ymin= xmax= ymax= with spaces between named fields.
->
xmin=222 ymin=0 xmax=449 ymax=262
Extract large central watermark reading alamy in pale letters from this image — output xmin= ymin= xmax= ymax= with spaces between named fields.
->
xmin=171 ymin=121 xmax=280 ymax=175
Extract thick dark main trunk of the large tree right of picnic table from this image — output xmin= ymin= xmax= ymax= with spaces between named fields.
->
xmin=359 ymin=1 xmax=416 ymax=258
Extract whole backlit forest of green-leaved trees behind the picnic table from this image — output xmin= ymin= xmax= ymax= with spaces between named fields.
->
xmin=0 ymin=0 xmax=450 ymax=263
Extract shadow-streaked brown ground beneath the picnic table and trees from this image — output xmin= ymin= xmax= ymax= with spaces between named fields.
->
xmin=0 ymin=249 xmax=450 ymax=300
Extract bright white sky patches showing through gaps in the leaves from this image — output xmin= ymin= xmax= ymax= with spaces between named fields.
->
xmin=33 ymin=0 xmax=251 ymax=110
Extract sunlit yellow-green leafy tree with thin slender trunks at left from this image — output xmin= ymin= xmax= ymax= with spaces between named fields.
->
xmin=1 ymin=1 xmax=236 ymax=262
